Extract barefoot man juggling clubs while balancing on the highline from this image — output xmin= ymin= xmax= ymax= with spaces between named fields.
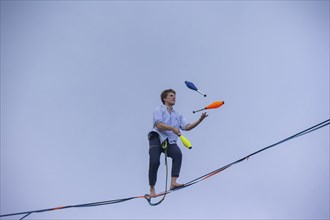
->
xmin=148 ymin=89 xmax=208 ymax=197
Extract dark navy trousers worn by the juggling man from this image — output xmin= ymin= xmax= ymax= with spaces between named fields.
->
xmin=148 ymin=132 xmax=182 ymax=186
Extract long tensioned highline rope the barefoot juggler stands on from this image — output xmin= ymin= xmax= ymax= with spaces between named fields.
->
xmin=0 ymin=119 xmax=330 ymax=219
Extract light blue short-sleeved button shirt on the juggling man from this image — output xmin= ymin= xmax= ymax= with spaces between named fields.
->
xmin=153 ymin=105 xmax=189 ymax=144
